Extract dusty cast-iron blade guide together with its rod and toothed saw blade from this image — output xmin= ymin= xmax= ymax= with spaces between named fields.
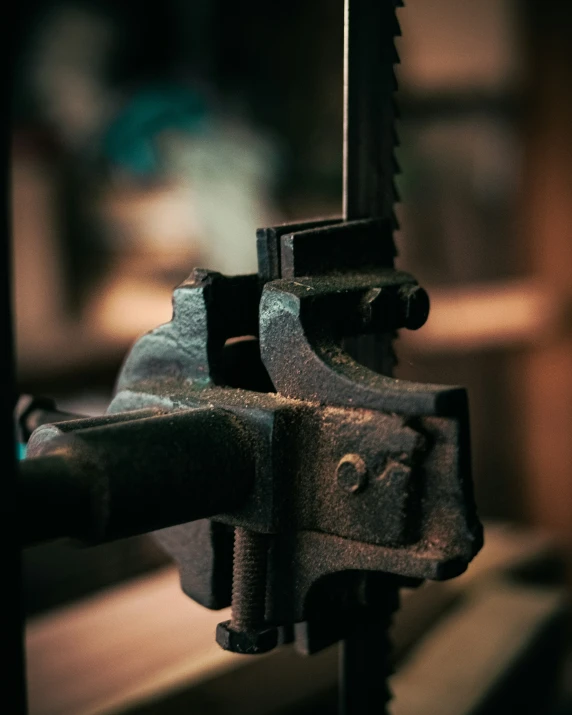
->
xmin=17 ymin=0 xmax=482 ymax=713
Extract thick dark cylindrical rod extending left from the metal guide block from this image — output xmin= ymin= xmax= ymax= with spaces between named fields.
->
xmin=18 ymin=408 xmax=254 ymax=544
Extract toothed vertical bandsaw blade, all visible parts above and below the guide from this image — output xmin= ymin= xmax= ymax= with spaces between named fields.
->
xmin=339 ymin=0 xmax=403 ymax=715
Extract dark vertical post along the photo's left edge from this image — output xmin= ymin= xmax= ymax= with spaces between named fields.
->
xmin=0 ymin=11 xmax=26 ymax=715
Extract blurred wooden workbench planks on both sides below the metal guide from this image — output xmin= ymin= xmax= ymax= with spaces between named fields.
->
xmin=26 ymin=526 xmax=567 ymax=715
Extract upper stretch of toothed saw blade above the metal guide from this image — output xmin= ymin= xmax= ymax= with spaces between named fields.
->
xmin=343 ymin=0 xmax=402 ymax=220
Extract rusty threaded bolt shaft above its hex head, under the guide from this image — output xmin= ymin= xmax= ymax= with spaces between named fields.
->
xmin=230 ymin=527 xmax=268 ymax=631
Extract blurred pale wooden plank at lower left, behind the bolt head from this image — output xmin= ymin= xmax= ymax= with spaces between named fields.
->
xmin=26 ymin=568 xmax=245 ymax=715
